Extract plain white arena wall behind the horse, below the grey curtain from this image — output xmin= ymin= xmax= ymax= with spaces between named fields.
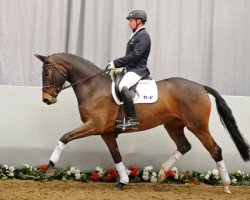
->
xmin=0 ymin=86 xmax=250 ymax=173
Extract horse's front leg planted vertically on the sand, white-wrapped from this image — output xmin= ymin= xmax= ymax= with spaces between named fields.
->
xmin=101 ymin=134 xmax=129 ymax=189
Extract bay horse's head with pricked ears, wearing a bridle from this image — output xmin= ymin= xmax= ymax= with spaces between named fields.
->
xmin=35 ymin=54 xmax=67 ymax=105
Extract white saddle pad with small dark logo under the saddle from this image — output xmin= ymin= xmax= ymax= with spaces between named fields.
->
xmin=111 ymin=79 xmax=158 ymax=105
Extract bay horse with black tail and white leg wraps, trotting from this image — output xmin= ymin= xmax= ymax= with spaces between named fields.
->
xmin=35 ymin=53 xmax=250 ymax=193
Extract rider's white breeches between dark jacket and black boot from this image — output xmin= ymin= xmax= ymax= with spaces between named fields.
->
xmin=119 ymin=72 xmax=142 ymax=92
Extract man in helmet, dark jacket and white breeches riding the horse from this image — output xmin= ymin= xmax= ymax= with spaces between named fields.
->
xmin=108 ymin=10 xmax=151 ymax=129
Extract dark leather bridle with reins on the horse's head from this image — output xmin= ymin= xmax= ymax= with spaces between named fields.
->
xmin=42 ymin=58 xmax=111 ymax=98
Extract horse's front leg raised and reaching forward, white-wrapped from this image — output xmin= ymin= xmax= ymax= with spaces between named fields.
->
xmin=48 ymin=121 xmax=96 ymax=169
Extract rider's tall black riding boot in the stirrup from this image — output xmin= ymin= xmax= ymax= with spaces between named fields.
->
xmin=116 ymin=87 xmax=138 ymax=129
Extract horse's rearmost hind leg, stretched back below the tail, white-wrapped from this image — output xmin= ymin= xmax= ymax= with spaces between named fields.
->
xmin=190 ymin=127 xmax=231 ymax=193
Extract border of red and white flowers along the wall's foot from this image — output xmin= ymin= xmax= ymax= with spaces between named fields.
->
xmin=0 ymin=164 xmax=250 ymax=186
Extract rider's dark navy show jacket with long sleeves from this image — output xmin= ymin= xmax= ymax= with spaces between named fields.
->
xmin=113 ymin=28 xmax=151 ymax=77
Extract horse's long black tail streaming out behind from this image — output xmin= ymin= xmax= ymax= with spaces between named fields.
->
xmin=204 ymin=86 xmax=250 ymax=161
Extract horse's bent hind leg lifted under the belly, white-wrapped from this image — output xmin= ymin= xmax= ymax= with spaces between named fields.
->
xmin=158 ymin=119 xmax=191 ymax=182
